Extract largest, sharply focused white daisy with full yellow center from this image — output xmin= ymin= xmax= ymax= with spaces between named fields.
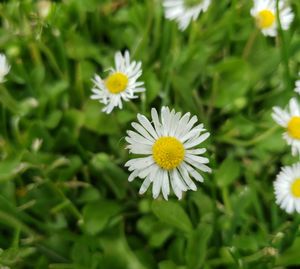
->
xmin=125 ymin=107 xmax=211 ymax=200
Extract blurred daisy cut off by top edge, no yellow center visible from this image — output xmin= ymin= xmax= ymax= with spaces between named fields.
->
xmin=163 ymin=0 xmax=211 ymax=31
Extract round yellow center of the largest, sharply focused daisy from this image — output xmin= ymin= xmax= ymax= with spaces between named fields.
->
xmin=152 ymin=136 xmax=184 ymax=170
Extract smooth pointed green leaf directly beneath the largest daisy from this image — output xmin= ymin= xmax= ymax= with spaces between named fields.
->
xmin=152 ymin=201 xmax=193 ymax=232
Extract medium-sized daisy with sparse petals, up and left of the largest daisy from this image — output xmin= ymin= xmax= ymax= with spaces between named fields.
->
xmin=91 ymin=51 xmax=145 ymax=114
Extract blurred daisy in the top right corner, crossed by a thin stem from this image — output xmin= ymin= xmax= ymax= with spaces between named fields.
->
xmin=250 ymin=0 xmax=294 ymax=36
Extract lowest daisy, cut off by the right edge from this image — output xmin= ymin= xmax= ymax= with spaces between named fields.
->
xmin=274 ymin=163 xmax=300 ymax=213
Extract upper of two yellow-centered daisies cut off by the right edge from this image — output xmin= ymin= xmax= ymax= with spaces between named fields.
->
xmin=272 ymin=98 xmax=300 ymax=155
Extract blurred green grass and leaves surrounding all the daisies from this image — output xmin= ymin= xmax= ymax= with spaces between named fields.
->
xmin=0 ymin=0 xmax=300 ymax=269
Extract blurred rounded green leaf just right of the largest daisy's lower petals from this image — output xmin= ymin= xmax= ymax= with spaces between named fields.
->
xmin=215 ymin=157 xmax=241 ymax=188
